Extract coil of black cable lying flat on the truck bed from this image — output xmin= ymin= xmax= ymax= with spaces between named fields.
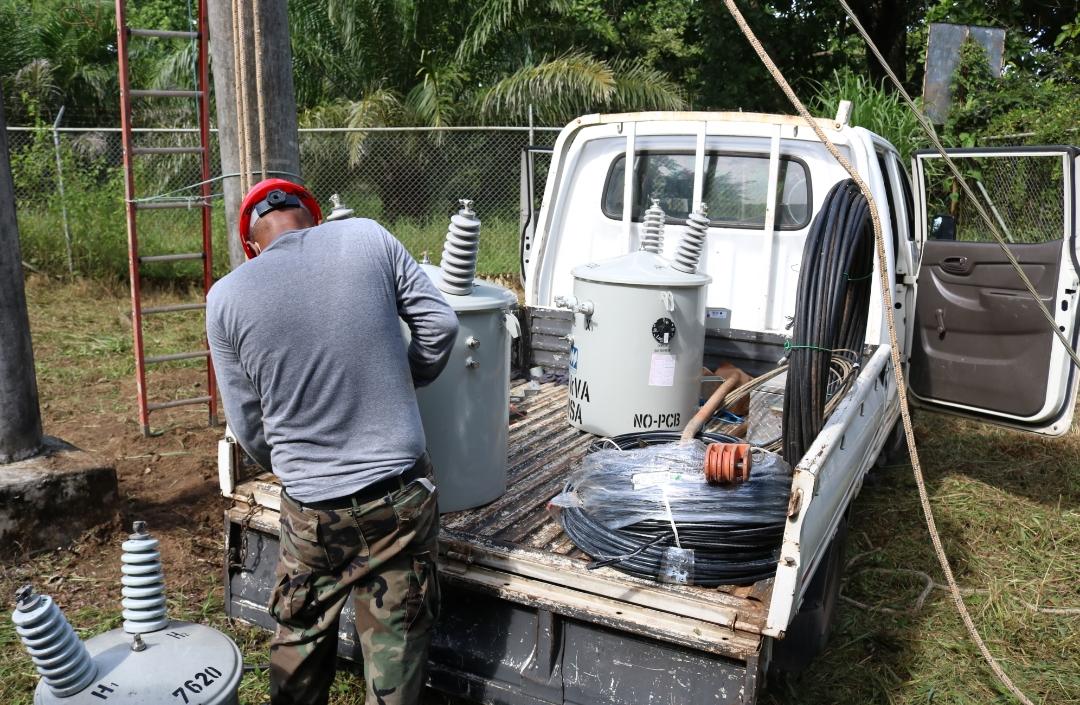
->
xmin=559 ymin=431 xmax=789 ymax=587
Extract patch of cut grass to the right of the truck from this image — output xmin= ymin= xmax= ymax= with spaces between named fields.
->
xmin=765 ymin=413 xmax=1080 ymax=705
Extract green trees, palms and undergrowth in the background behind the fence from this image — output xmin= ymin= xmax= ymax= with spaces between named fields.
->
xmin=0 ymin=0 xmax=1080 ymax=280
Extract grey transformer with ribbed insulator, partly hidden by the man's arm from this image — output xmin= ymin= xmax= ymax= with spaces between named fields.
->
xmin=416 ymin=201 xmax=518 ymax=513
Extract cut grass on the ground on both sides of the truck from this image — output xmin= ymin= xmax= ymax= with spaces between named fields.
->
xmin=0 ymin=277 xmax=1080 ymax=705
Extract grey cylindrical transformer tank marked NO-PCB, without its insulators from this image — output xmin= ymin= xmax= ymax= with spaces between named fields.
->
xmin=555 ymin=250 xmax=712 ymax=436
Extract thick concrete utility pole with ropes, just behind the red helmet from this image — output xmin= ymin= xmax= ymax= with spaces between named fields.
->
xmin=207 ymin=0 xmax=300 ymax=268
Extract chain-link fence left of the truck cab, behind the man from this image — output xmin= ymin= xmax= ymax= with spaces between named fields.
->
xmin=8 ymin=126 xmax=558 ymax=280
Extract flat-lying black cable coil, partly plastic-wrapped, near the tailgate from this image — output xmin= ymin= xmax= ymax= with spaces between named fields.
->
xmin=558 ymin=432 xmax=791 ymax=587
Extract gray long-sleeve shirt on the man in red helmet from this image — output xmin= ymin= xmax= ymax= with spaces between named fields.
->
xmin=206 ymin=218 xmax=458 ymax=502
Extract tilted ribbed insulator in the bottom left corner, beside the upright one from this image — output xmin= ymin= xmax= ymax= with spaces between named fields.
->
xmin=11 ymin=585 xmax=97 ymax=697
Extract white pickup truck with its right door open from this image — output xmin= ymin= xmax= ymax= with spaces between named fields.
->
xmin=219 ymin=112 xmax=1080 ymax=705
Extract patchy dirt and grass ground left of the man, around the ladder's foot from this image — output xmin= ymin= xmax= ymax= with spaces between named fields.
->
xmin=0 ymin=276 xmax=300 ymax=703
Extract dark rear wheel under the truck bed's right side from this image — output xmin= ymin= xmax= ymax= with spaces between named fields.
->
xmin=772 ymin=517 xmax=848 ymax=673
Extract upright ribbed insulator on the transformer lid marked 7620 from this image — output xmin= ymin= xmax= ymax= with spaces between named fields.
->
xmin=120 ymin=521 xmax=168 ymax=634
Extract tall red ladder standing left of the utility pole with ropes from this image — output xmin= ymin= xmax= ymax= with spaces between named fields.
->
xmin=116 ymin=0 xmax=217 ymax=435
